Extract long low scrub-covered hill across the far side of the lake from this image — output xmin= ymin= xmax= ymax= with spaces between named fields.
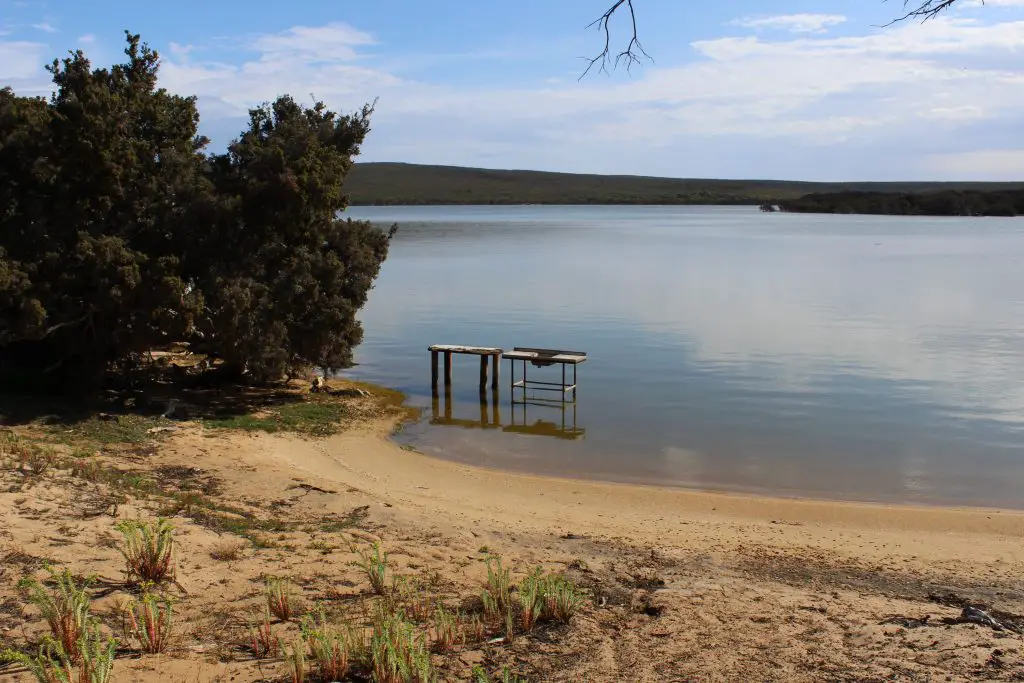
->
xmin=345 ymin=163 xmax=1024 ymax=205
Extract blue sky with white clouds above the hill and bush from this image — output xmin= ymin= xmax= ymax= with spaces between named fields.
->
xmin=0 ymin=0 xmax=1024 ymax=180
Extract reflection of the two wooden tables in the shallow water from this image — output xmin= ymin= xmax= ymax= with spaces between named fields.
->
xmin=430 ymin=391 xmax=587 ymax=440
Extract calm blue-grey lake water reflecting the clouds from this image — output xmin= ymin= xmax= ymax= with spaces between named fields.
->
xmin=342 ymin=207 xmax=1024 ymax=508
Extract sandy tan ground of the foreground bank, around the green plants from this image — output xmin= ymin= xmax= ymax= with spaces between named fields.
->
xmin=0 ymin=384 xmax=1024 ymax=683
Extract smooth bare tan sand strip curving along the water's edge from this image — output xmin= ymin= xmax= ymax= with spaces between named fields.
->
xmin=301 ymin=425 xmax=1024 ymax=579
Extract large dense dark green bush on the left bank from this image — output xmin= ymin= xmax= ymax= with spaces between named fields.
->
xmin=0 ymin=35 xmax=388 ymax=387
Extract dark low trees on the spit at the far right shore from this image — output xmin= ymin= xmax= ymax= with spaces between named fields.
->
xmin=779 ymin=189 xmax=1024 ymax=216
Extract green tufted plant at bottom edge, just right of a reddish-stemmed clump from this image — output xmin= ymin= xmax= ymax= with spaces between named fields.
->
xmin=370 ymin=607 xmax=434 ymax=683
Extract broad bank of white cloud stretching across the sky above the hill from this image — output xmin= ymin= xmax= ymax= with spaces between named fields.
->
xmin=9 ymin=15 xmax=1024 ymax=179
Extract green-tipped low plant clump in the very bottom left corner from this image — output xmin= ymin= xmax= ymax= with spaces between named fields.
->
xmin=0 ymin=622 xmax=117 ymax=683
